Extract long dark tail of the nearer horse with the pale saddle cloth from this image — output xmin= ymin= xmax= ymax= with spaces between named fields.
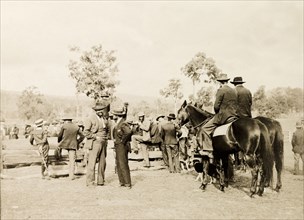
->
xmin=259 ymin=122 xmax=274 ymax=183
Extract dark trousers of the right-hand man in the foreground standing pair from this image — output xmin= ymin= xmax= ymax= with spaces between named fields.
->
xmin=115 ymin=143 xmax=131 ymax=186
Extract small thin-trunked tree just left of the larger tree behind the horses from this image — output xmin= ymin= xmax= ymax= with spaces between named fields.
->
xmin=160 ymin=79 xmax=183 ymax=113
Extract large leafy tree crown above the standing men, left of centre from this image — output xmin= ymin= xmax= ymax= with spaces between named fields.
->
xmin=69 ymin=45 xmax=119 ymax=103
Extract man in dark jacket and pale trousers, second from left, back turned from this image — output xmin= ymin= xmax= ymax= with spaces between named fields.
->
xmin=58 ymin=116 xmax=84 ymax=180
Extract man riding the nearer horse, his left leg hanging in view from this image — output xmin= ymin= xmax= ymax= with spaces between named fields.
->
xmin=198 ymin=74 xmax=237 ymax=163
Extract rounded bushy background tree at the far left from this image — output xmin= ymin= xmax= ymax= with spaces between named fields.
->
xmin=17 ymin=86 xmax=45 ymax=120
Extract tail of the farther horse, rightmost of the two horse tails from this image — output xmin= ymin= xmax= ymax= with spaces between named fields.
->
xmin=272 ymin=121 xmax=284 ymax=173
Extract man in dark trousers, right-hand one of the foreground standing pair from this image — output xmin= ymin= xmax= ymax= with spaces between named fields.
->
xmin=112 ymin=107 xmax=132 ymax=188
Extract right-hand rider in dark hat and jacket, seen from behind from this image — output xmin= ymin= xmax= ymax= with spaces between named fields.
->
xmin=230 ymin=76 xmax=252 ymax=118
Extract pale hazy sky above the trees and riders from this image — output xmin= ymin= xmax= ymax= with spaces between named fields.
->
xmin=1 ymin=1 xmax=303 ymax=97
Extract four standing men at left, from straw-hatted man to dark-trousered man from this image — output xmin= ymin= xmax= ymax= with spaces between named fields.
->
xmin=30 ymin=93 xmax=131 ymax=188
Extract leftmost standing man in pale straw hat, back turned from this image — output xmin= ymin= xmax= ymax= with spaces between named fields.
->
xmin=30 ymin=118 xmax=50 ymax=179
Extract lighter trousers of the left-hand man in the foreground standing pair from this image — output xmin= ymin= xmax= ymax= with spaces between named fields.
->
xmin=86 ymin=140 xmax=108 ymax=185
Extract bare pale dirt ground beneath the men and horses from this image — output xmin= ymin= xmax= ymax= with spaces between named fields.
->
xmin=1 ymin=117 xmax=304 ymax=219
